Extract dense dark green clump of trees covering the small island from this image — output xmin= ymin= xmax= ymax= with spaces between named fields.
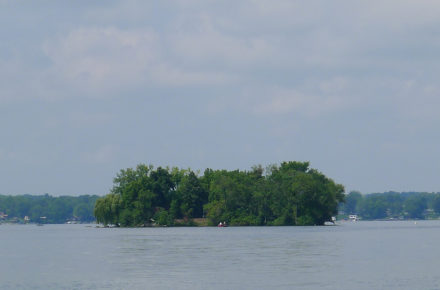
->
xmin=94 ymin=161 xmax=344 ymax=227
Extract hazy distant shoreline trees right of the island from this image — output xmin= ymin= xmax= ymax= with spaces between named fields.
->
xmin=340 ymin=191 xmax=440 ymax=220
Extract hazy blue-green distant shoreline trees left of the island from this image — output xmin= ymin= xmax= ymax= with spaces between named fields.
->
xmin=0 ymin=194 xmax=98 ymax=224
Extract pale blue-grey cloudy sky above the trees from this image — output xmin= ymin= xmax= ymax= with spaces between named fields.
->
xmin=0 ymin=0 xmax=440 ymax=195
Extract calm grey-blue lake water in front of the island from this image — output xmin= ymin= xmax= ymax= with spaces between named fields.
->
xmin=0 ymin=221 xmax=440 ymax=290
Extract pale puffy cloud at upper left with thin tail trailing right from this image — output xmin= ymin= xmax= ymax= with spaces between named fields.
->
xmin=44 ymin=28 xmax=235 ymax=95
